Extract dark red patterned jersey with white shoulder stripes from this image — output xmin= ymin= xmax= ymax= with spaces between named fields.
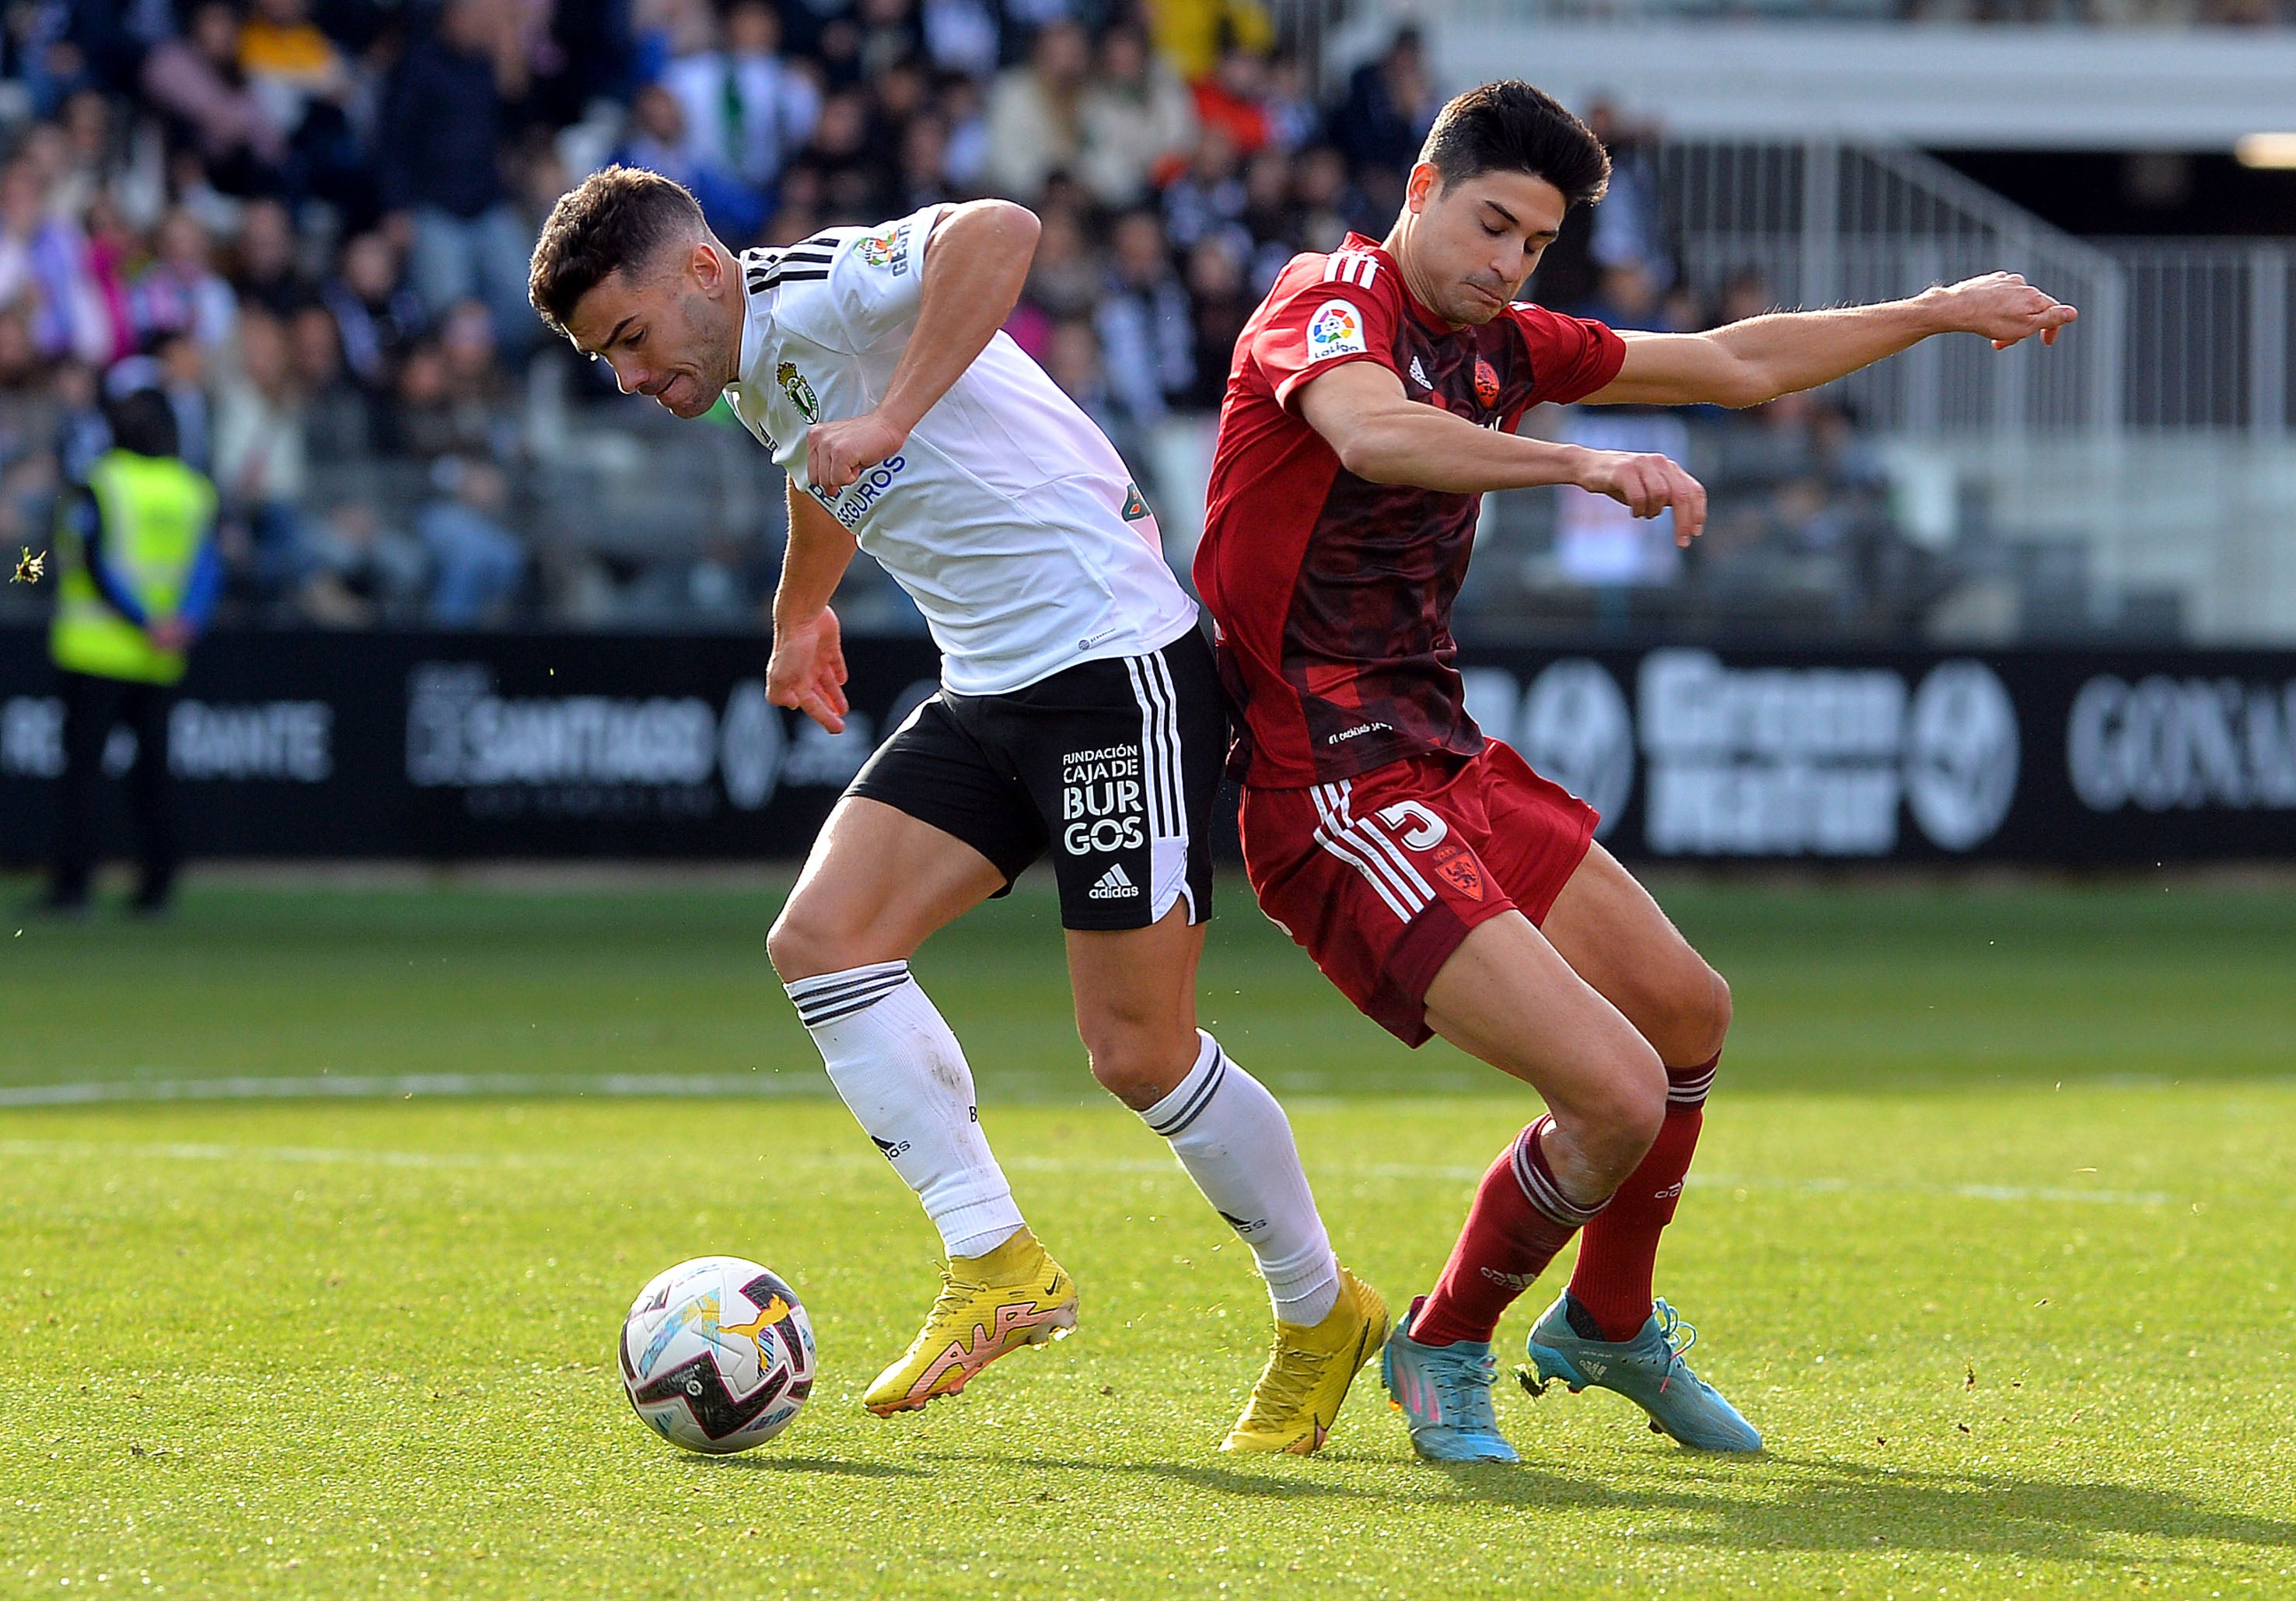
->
xmin=1197 ymin=234 xmax=1626 ymax=788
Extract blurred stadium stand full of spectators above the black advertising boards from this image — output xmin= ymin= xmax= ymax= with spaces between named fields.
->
xmin=0 ymin=0 xmax=2296 ymax=643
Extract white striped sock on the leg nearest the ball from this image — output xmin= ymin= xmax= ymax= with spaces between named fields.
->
xmin=788 ymin=963 xmax=1022 ymax=1257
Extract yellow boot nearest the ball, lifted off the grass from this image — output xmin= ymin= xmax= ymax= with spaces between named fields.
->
xmin=861 ymin=1229 xmax=1077 ymax=1417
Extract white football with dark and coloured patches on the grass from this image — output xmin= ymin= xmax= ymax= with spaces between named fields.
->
xmin=620 ymin=1257 xmax=813 ymax=1456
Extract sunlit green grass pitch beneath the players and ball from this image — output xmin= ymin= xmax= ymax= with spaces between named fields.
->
xmin=0 ymin=884 xmax=2296 ymax=1596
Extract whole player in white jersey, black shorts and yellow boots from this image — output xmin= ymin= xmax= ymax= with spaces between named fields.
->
xmin=530 ymin=168 xmax=1389 ymax=1454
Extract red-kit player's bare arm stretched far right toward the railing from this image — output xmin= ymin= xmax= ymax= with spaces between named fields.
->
xmin=1587 ymin=274 xmax=2080 ymax=407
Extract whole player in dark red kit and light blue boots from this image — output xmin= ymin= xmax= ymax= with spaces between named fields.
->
xmin=1197 ymin=82 xmax=2076 ymax=1461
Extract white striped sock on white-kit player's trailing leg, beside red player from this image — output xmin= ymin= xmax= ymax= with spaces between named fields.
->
xmin=1141 ymin=1029 xmax=1339 ymax=1323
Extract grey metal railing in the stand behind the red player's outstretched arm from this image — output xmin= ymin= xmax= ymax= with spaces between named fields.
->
xmin=1655 ymin=142 xmax=2296 ymax=441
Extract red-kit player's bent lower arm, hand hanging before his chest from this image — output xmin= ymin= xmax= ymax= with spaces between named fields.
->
xmin=1297 ymin=361 xmax=1706 ymax=544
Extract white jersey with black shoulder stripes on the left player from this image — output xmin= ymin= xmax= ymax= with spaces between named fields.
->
xmin=725 ymin=207 xmax=1197 ymax=694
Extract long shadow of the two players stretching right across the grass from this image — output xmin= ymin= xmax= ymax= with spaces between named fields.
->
xmin=944 ymin=1452 xmax=2296 ymax=1564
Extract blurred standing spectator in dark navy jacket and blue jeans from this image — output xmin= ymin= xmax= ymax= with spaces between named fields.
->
xmin=376 ymin=0 xmax=540 ymax=349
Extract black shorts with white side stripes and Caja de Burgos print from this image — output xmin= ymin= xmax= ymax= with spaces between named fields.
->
xmin=845 ymin=629 xmax=1228 ymax=928
